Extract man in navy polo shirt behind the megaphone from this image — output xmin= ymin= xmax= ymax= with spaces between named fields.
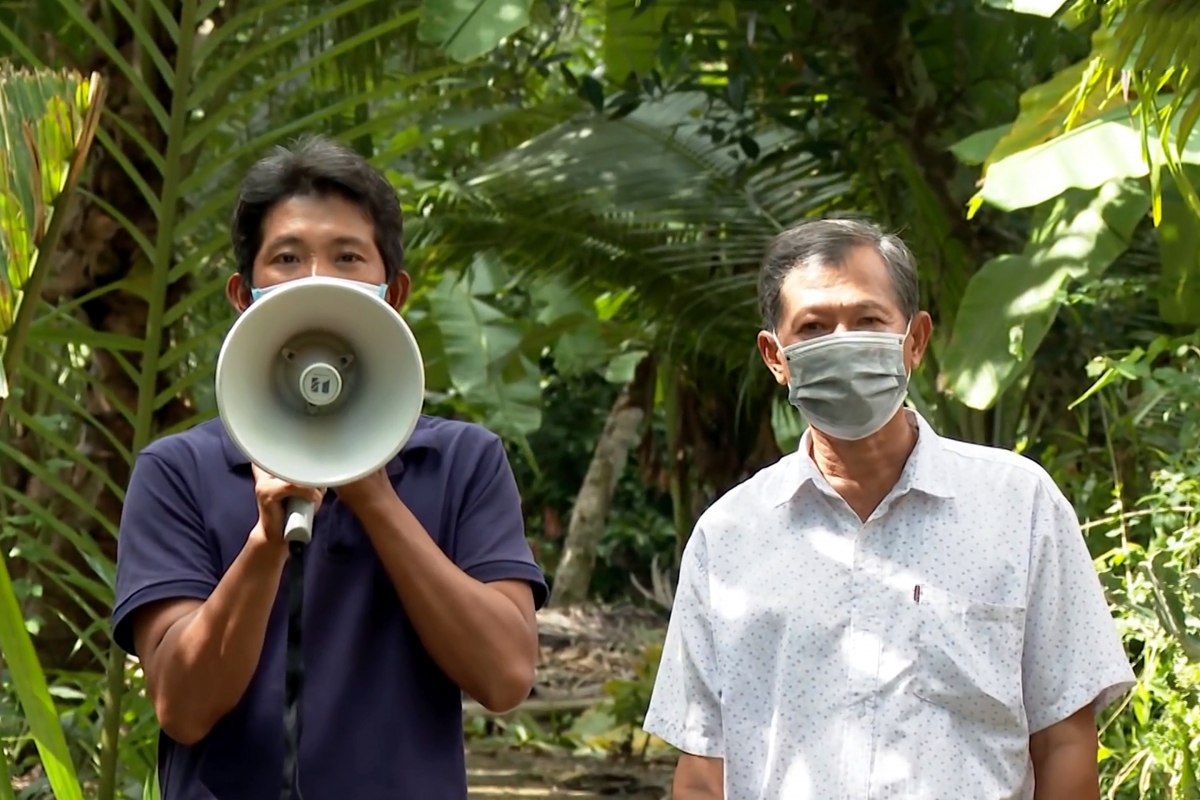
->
xmin=113 ymin=138 xmax=546 ymax=800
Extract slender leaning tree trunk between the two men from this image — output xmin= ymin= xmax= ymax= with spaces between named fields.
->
xmin=548 ymin=359 xmax=653 ymax=608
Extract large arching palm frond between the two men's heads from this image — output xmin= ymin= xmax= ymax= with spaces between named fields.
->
xmin=419 ymin=92 xmax=847 ymax=366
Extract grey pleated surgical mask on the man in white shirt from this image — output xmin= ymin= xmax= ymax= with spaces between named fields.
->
xmin=775 ymin=330 xmax=908 ymax=441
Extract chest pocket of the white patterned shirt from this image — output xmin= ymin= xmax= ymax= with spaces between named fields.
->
xmin=913 ymin=584 xmax=1025 ymax=722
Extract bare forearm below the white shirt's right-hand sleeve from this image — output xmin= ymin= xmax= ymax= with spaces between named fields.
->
xmin=1030 ymin=705 xmax=1100 ymax=800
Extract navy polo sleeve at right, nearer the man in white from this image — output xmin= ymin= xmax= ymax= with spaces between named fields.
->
xmin=454 ymin=435 xmax=548 ymax=608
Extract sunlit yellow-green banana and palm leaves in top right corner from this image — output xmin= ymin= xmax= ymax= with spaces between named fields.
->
xmin=947 ymin=0 xmax=1200 ymax=419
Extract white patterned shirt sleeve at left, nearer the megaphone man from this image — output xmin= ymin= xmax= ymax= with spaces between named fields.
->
xmin=642 ymin=527 xmax=725 ymax=758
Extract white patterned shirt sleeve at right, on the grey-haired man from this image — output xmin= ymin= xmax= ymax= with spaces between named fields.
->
xmin=1021 ymin=479 xmax=1136 ymax=733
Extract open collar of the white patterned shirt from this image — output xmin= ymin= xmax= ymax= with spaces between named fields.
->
xmin=772 ymin=409 xmax=954 ymax=505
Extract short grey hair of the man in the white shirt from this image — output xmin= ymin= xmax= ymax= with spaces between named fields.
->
xmin=758 ymin=217 xmax=920 ymax=331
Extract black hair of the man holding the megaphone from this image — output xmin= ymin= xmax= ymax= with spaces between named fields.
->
xmin=230 ymin=134 xmax=404 ymax=283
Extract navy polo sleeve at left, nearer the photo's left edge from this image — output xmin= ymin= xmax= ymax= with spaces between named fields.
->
xmin=113 ymin=451 xmax=221 ymax=655
